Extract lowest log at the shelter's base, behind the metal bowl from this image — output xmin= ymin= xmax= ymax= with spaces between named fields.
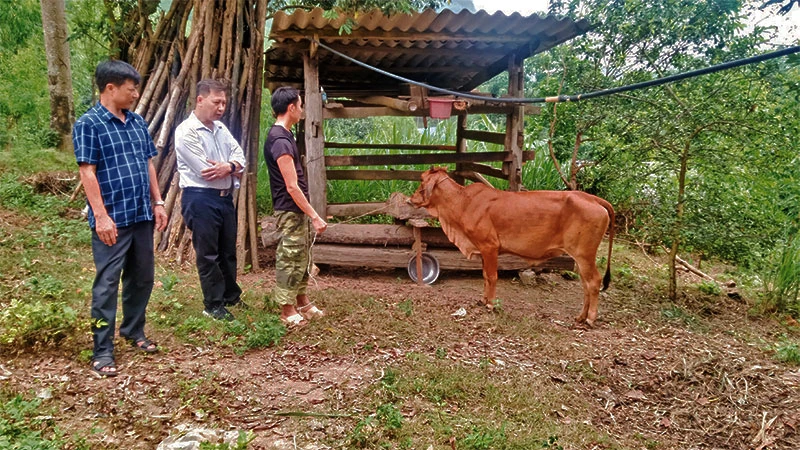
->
xmin=312 ymin=244 xmax=575 ymax=271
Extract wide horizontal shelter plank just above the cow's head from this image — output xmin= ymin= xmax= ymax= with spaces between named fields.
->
xmin=325 ymin=152 xmax=510 ymax=167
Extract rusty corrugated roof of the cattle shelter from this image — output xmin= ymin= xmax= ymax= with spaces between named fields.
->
xmin=265 ymin=8 xmax=589 ymax=96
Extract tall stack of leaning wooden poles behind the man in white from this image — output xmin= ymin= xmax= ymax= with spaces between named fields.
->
xmin=120 ymin=0 xmax=269 ymax=270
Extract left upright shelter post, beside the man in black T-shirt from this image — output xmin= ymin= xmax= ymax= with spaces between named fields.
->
xmin=303 ymin=42 xmax=328 ymax=217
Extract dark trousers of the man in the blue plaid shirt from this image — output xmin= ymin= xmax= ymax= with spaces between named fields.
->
xmin=92 ymin=221 xmax=154 ymax=357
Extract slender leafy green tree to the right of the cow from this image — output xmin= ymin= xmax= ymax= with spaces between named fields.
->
xmin=532 ymin=0 xmax=788 ymax=299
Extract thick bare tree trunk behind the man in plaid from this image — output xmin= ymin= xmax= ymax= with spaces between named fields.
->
xmin=40 ymin=0 xmax=75 ymax=152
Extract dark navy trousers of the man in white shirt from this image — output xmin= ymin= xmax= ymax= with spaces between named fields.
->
xmin=181 ymin=188 xmax=242 ymax=311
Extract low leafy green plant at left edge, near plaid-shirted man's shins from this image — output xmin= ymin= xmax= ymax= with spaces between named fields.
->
xmin=0 ymin=300 xmax=82 ymax=348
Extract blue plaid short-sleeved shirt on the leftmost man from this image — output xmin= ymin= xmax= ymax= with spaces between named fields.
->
xmin=72 ymin=102 xmax=158 ymax=229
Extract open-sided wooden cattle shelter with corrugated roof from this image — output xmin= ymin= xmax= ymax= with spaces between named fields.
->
xmin=265 ymin=8 xmax=589 ymax=273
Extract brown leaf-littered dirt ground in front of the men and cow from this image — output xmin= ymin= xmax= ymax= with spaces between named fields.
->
xmin=0 ymin=255 xmax=800 ymax=449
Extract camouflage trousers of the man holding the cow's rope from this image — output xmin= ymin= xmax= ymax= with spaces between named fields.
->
xmin=272 ymin=211 xmax=311 ymax=305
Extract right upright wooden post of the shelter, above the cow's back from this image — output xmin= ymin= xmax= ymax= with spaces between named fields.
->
xmin=503 ymin=55 xmax=525 ymax=191
